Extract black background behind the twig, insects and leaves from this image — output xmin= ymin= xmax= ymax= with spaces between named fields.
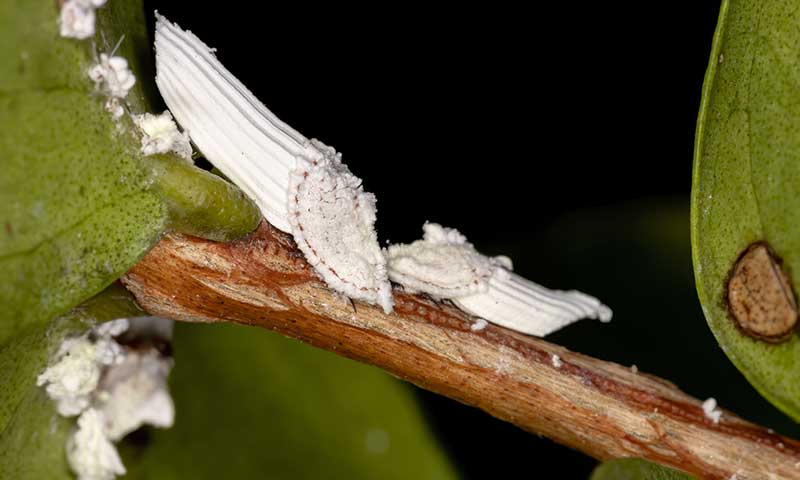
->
xmin=146 ymin=1 xmax=798 ymax=478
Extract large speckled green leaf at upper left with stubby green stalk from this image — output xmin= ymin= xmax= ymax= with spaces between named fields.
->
xmin=0 ymin=0 xmax=260 ymax=346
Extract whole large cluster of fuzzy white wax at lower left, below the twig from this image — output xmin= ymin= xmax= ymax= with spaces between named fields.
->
xmin=37 ymin=317 xmax=175 ymax=480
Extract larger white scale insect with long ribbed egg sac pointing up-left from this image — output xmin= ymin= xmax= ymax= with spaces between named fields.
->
xmin=155 ymin=13 xmax=392 ymax=313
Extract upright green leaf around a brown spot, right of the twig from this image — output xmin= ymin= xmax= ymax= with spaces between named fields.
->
xmin=691 ymin=0 xmax=800 ymax=420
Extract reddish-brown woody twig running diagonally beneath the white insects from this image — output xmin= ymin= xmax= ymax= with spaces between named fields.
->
xmin=123 ymin=223 xmax=800 ymax=479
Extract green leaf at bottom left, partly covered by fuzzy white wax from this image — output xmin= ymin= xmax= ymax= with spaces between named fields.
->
xmin=0 ymin=285 xmax=142 ymax=480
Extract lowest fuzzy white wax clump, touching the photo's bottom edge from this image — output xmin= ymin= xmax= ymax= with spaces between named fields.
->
xmin=67 ymin=408 xmax=126 ymax=480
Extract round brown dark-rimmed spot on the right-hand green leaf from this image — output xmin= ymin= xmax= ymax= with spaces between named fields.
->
xmin=727 ymin=242 xmax=797 ymax=343
